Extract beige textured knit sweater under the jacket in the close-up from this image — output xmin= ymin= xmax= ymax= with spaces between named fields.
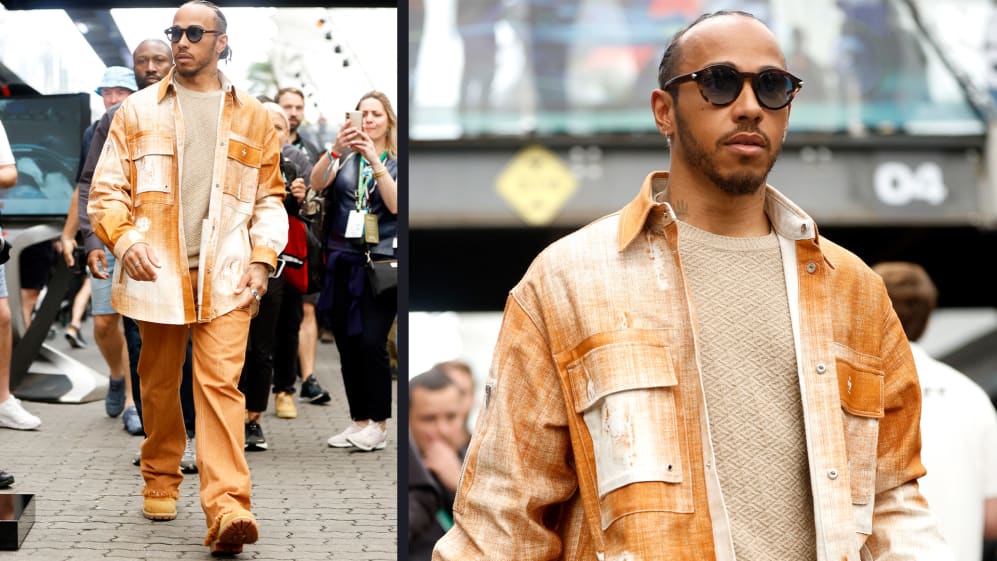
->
xmin=678 ymin=222 xmax=816 ymax=561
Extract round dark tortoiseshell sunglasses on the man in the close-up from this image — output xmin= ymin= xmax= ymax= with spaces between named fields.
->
xmin=662 ymin=64 xmax=803 ymax=110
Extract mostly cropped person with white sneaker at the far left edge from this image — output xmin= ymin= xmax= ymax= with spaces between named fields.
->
xmin=0 ymin=123 xmax=42 ymax=434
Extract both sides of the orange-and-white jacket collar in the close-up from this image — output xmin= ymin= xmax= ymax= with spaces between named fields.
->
xmin=617 ymin=171 xmax=818 ymax=251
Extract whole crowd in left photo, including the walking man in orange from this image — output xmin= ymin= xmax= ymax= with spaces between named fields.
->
xmin=0 ymin=0 xmax=398 ymax=555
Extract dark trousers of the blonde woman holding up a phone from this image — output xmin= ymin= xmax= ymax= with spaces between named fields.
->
xmin=330 ymin=263 xmax=398 ymax=421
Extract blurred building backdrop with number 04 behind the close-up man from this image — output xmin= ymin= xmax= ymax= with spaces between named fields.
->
xmin=408 ymin=0 xmax=997 ymax=420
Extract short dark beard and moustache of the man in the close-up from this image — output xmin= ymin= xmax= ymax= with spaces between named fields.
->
xmin=675 ymin=111 xmax=782 ymax=195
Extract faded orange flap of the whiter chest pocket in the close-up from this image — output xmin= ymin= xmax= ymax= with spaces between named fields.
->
xmin=568 ymin=341 xmax=678 ymax=413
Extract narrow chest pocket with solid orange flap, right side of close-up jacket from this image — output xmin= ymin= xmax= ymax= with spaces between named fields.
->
xmin=836 ymin=358 xmax=885 ymax=533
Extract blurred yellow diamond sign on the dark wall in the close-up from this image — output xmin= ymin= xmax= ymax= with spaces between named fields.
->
xmin=495 ymin=146 xmax=578 ymax=226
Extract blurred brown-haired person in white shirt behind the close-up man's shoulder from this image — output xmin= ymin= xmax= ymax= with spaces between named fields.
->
xmin=872 ymin=261 xmax=997 ymax=559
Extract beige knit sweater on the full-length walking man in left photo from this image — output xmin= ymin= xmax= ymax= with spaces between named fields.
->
xmin=176 ymin=80 xmax=222 ymax=269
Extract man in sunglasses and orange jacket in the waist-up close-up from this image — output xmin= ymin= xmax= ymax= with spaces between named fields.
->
xmin=434 ymin=11 xmax=951 ymax=561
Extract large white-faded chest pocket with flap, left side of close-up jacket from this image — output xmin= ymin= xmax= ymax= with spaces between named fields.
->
xmin=567 ymin=341 xmax=693 ymax=529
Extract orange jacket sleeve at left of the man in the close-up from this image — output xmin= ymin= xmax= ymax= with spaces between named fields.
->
xmin=433 ymin=297 xmax=577 ymax=561
